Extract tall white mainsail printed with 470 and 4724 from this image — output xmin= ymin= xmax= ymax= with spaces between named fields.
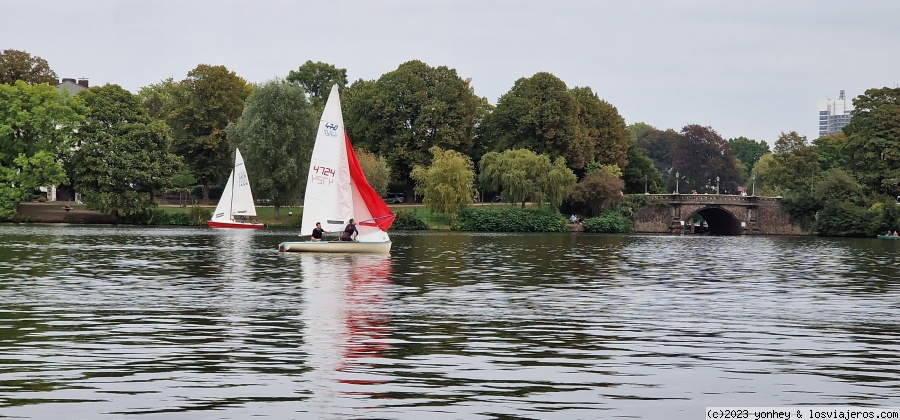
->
xmin=300 ymin=86 xmax=353 ymax=235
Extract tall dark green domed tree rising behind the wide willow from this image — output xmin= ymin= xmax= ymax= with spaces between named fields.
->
xmin=482 ymin=72 xmax=590 ymax=169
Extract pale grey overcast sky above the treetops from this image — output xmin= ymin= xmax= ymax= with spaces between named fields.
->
xmin=7 ymin=0 xmax=900 ymax=145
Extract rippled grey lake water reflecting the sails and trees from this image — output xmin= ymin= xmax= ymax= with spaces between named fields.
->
xmin=0 ymin=225 xmax=900 ymax=419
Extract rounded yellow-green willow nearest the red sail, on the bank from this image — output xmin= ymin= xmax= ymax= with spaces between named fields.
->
xmin=411 ymin=146 xmax=475 ymax=215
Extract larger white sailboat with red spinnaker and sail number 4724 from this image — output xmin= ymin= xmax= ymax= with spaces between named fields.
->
xmin=278 ymin=85 xmax=394 ymax=253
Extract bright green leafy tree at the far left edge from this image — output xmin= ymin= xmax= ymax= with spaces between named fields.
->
xmin=0 ymin=80 xmax=84 ymax=219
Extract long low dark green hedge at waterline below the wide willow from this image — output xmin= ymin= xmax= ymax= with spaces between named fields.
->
xmin=450 ymin=206 xmax=567 ymax=232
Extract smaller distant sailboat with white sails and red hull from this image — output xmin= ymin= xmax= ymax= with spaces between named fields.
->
xmin=206 ymin=149 xmax=265 ymax=229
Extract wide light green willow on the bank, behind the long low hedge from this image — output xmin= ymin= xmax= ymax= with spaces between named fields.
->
xmin=478 ymin=149 xmax=577 ymax=208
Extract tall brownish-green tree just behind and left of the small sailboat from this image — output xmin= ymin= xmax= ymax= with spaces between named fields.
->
xmin=169 ymin=64 xmax=253 ymax=202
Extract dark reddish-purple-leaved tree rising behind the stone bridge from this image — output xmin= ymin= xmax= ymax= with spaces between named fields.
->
xmin=669 ymin=124 xmax=741 ymax=194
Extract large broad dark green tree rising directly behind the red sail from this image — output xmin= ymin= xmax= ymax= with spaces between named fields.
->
xmin=343 ymin=61 xmax=486 ymax=195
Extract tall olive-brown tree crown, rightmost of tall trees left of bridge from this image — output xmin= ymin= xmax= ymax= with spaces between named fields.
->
xmin=571 ymin=87 xmax=629 ymax=168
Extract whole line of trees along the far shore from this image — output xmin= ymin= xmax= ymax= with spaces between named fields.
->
xmin=0 ymin=50 xmax=900 ymax=232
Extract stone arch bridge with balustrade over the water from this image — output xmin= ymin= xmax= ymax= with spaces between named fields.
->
xmin=634 ymin=194 xmax=809 ymax=235
